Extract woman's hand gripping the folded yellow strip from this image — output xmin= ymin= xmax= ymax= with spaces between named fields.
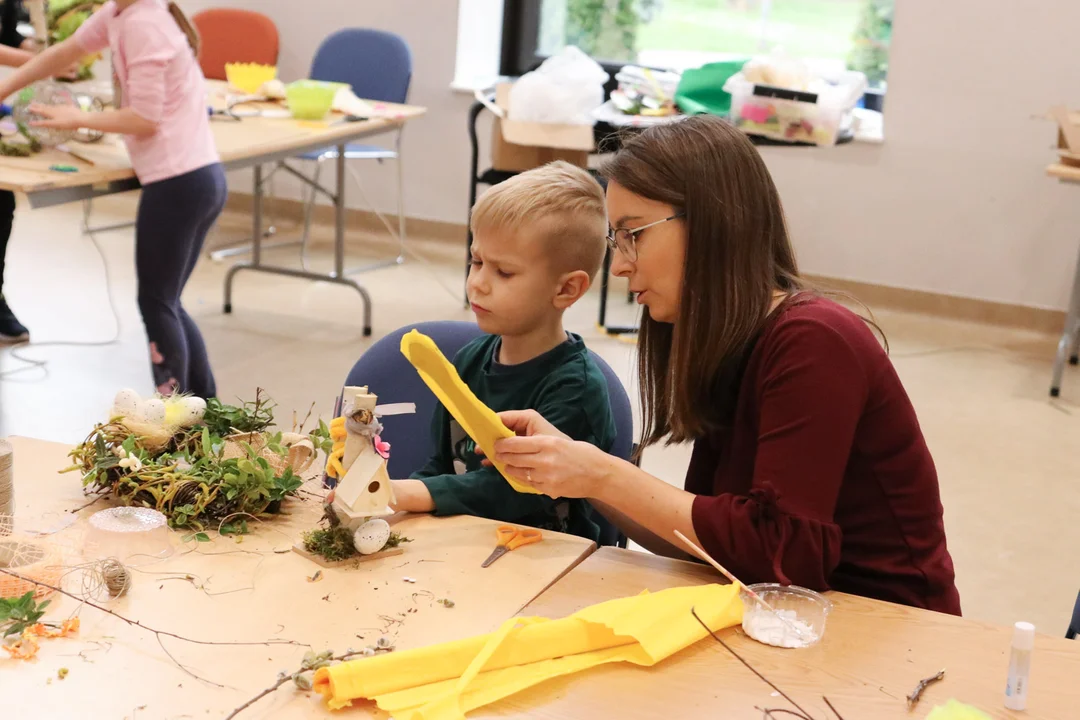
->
xmin=495 ymin=410 xmax=617 ymax=498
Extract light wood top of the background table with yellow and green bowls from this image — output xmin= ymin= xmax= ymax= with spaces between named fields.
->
xmin=0 ymin=82 xmax=426 ymax=204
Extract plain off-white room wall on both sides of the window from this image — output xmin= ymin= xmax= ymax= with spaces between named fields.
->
xmin=183 ymin=0 xmax=1080 ymax=309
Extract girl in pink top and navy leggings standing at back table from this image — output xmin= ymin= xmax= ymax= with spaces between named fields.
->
xmin=0 ymin=0 xmax=226 ymax=397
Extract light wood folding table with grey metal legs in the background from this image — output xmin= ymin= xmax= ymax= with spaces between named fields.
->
xmin=0 ymin=82 xmax=427 ymax=336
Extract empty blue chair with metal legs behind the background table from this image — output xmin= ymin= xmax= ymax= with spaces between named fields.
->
xmin=298 ymin=28 xmax=413 ymax=267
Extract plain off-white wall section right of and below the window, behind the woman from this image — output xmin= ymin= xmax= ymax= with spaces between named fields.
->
xmin=764 ymin=0 xmax=1080 ymax=309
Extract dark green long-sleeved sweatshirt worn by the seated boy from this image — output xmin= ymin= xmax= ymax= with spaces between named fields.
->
xmin=413 ymin=332 xmax=615 ymax=540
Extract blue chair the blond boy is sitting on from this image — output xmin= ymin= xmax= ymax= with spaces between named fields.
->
xmin=339 ymin=321 xmax=634 ymax=547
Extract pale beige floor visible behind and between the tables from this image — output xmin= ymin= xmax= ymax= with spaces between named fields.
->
xmin=0 ymin=191 xmax=1080 ymax=635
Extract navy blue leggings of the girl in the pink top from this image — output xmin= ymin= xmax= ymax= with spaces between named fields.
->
xmin=135 ymin=164 xmax=227 ymax=397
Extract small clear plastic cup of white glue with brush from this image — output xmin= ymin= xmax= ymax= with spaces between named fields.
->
xmin=739 ymin=583 xmax=833 ymax=648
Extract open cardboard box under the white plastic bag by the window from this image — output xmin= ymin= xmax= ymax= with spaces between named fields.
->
xmin=491 ymin=83 xmax=595 ymax=173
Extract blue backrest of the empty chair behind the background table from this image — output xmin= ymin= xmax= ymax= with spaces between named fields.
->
xmin=311 ymin=28 xmax=413 ymax=103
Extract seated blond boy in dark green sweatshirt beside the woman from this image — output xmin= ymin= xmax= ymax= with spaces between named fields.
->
xmin=393 ymin=162 xmax=615 ymax=540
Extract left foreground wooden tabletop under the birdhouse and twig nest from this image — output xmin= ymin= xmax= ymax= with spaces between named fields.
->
xmin=0 ymin=438 xmax=594 ymax=720
